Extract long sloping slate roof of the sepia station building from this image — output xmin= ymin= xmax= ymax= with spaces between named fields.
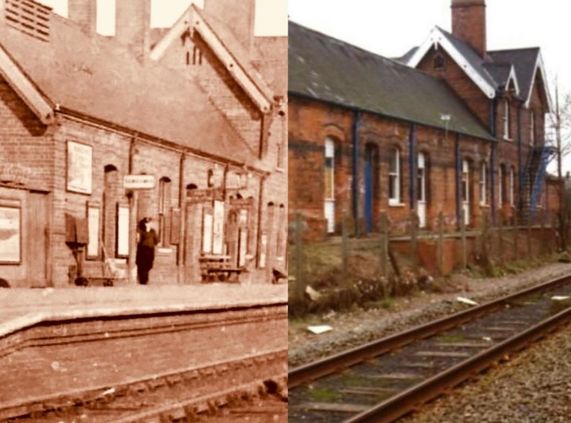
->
xmin=0 ymin=13 xmax=258 ymax=165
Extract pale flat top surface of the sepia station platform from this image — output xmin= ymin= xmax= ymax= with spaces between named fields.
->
xmin=0 ymin=283 xmax=288 ymax=337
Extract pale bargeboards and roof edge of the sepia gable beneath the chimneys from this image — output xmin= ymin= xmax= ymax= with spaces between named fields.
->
xmin=150 ymin=4 xmax=273 ymax=113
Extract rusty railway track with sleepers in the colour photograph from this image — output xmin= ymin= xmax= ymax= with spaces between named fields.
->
xmin=288 ymin=275 xmax=571 ymax=423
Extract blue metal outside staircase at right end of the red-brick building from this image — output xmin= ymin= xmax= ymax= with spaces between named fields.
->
xmin=520 ymin=143 xmax=557 ymax=223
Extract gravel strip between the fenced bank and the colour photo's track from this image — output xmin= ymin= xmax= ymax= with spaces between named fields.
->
xmin=288 ymin=263 xmax=571 ymax=368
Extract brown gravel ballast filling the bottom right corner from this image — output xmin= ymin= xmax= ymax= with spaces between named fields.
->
xmin=402 ymin=326 xmax=571 ymax=423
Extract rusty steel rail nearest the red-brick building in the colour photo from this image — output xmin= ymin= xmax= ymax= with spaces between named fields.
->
xmin=288 ymin=275 xmax=571 ymax=389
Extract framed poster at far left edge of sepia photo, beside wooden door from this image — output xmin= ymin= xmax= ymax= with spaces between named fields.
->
xmin=0 ymin=204 xmax=22 ymax=264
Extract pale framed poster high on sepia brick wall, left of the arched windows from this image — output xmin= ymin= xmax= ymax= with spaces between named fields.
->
xmin=66 ymin=141 xmax=93 ymax=194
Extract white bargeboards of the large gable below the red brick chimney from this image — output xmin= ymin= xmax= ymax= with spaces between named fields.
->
xmin=407 ymin=26 xmax=496 ymax=98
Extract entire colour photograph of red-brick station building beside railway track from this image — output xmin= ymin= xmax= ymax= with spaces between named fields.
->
xmin=288 ymin=0 xmax=571 ymax=423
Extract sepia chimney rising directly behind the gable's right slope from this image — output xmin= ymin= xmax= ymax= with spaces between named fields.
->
xmin=204 ymin=0 xmax=256 ymax=49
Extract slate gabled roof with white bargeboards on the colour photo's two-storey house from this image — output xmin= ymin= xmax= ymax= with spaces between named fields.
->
xmin=403 ymin=26 xmax=552 ymax=110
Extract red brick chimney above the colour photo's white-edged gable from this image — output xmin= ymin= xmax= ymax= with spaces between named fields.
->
xmin=452 ymin=0 xmax=487 ymax=57
